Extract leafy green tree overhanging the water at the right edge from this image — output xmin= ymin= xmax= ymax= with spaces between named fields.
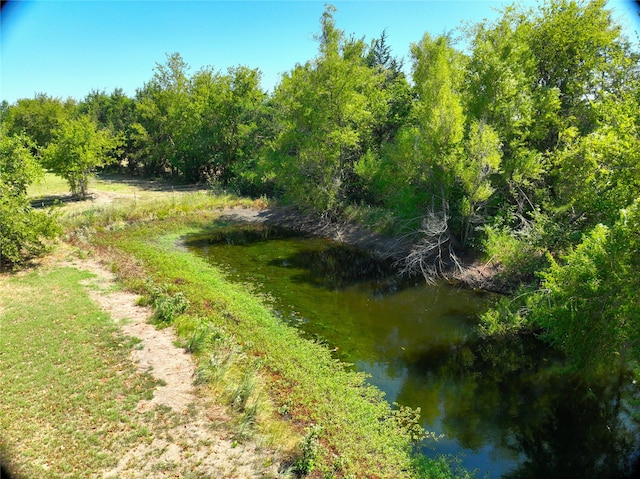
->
xmin=528 ymin=200 xmax=640 ymax=371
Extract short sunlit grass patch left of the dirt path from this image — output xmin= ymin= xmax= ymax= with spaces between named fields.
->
xmin=0 ymin=268 xmax=155 ymax=478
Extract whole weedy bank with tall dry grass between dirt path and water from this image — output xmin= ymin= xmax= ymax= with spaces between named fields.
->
xmin=86 ymin=216 xmax=424 ymax=478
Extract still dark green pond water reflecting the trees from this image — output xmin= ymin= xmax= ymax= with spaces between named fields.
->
xmin=184 ymin=222 xmax=640 ymax=479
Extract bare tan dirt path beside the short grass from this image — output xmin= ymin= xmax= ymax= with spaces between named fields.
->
xmin=65 ymin=259 xmax=280 ymax=479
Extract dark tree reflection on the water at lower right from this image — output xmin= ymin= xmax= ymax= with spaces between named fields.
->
xmin=397 ymin=337 xmax=640 ymax=479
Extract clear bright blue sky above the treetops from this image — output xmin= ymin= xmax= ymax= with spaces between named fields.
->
xmin=0 ymin=0 xmax=640 ymax=103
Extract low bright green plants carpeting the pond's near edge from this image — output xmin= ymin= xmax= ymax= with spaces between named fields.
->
xmin=90 ymin=216 xmax=420 ymax=478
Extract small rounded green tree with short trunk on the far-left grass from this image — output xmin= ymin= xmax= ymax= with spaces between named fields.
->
xmin=43 ymin=115 xmax=120 ymax=199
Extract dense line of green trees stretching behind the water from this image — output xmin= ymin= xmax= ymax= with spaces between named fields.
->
xmin=1 ymin=0 xmax=640 ymax=372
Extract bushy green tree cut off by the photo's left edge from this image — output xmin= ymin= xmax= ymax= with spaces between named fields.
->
xmin=0 ymin=131 xmax=59 ymax=271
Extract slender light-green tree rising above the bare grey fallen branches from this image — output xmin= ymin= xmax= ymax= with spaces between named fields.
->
xmin=380 ymin=34 xmax=466 ymax=225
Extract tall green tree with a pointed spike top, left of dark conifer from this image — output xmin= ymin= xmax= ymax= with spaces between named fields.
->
xmin=269 ymin=6 xmax=387 ymax=215
